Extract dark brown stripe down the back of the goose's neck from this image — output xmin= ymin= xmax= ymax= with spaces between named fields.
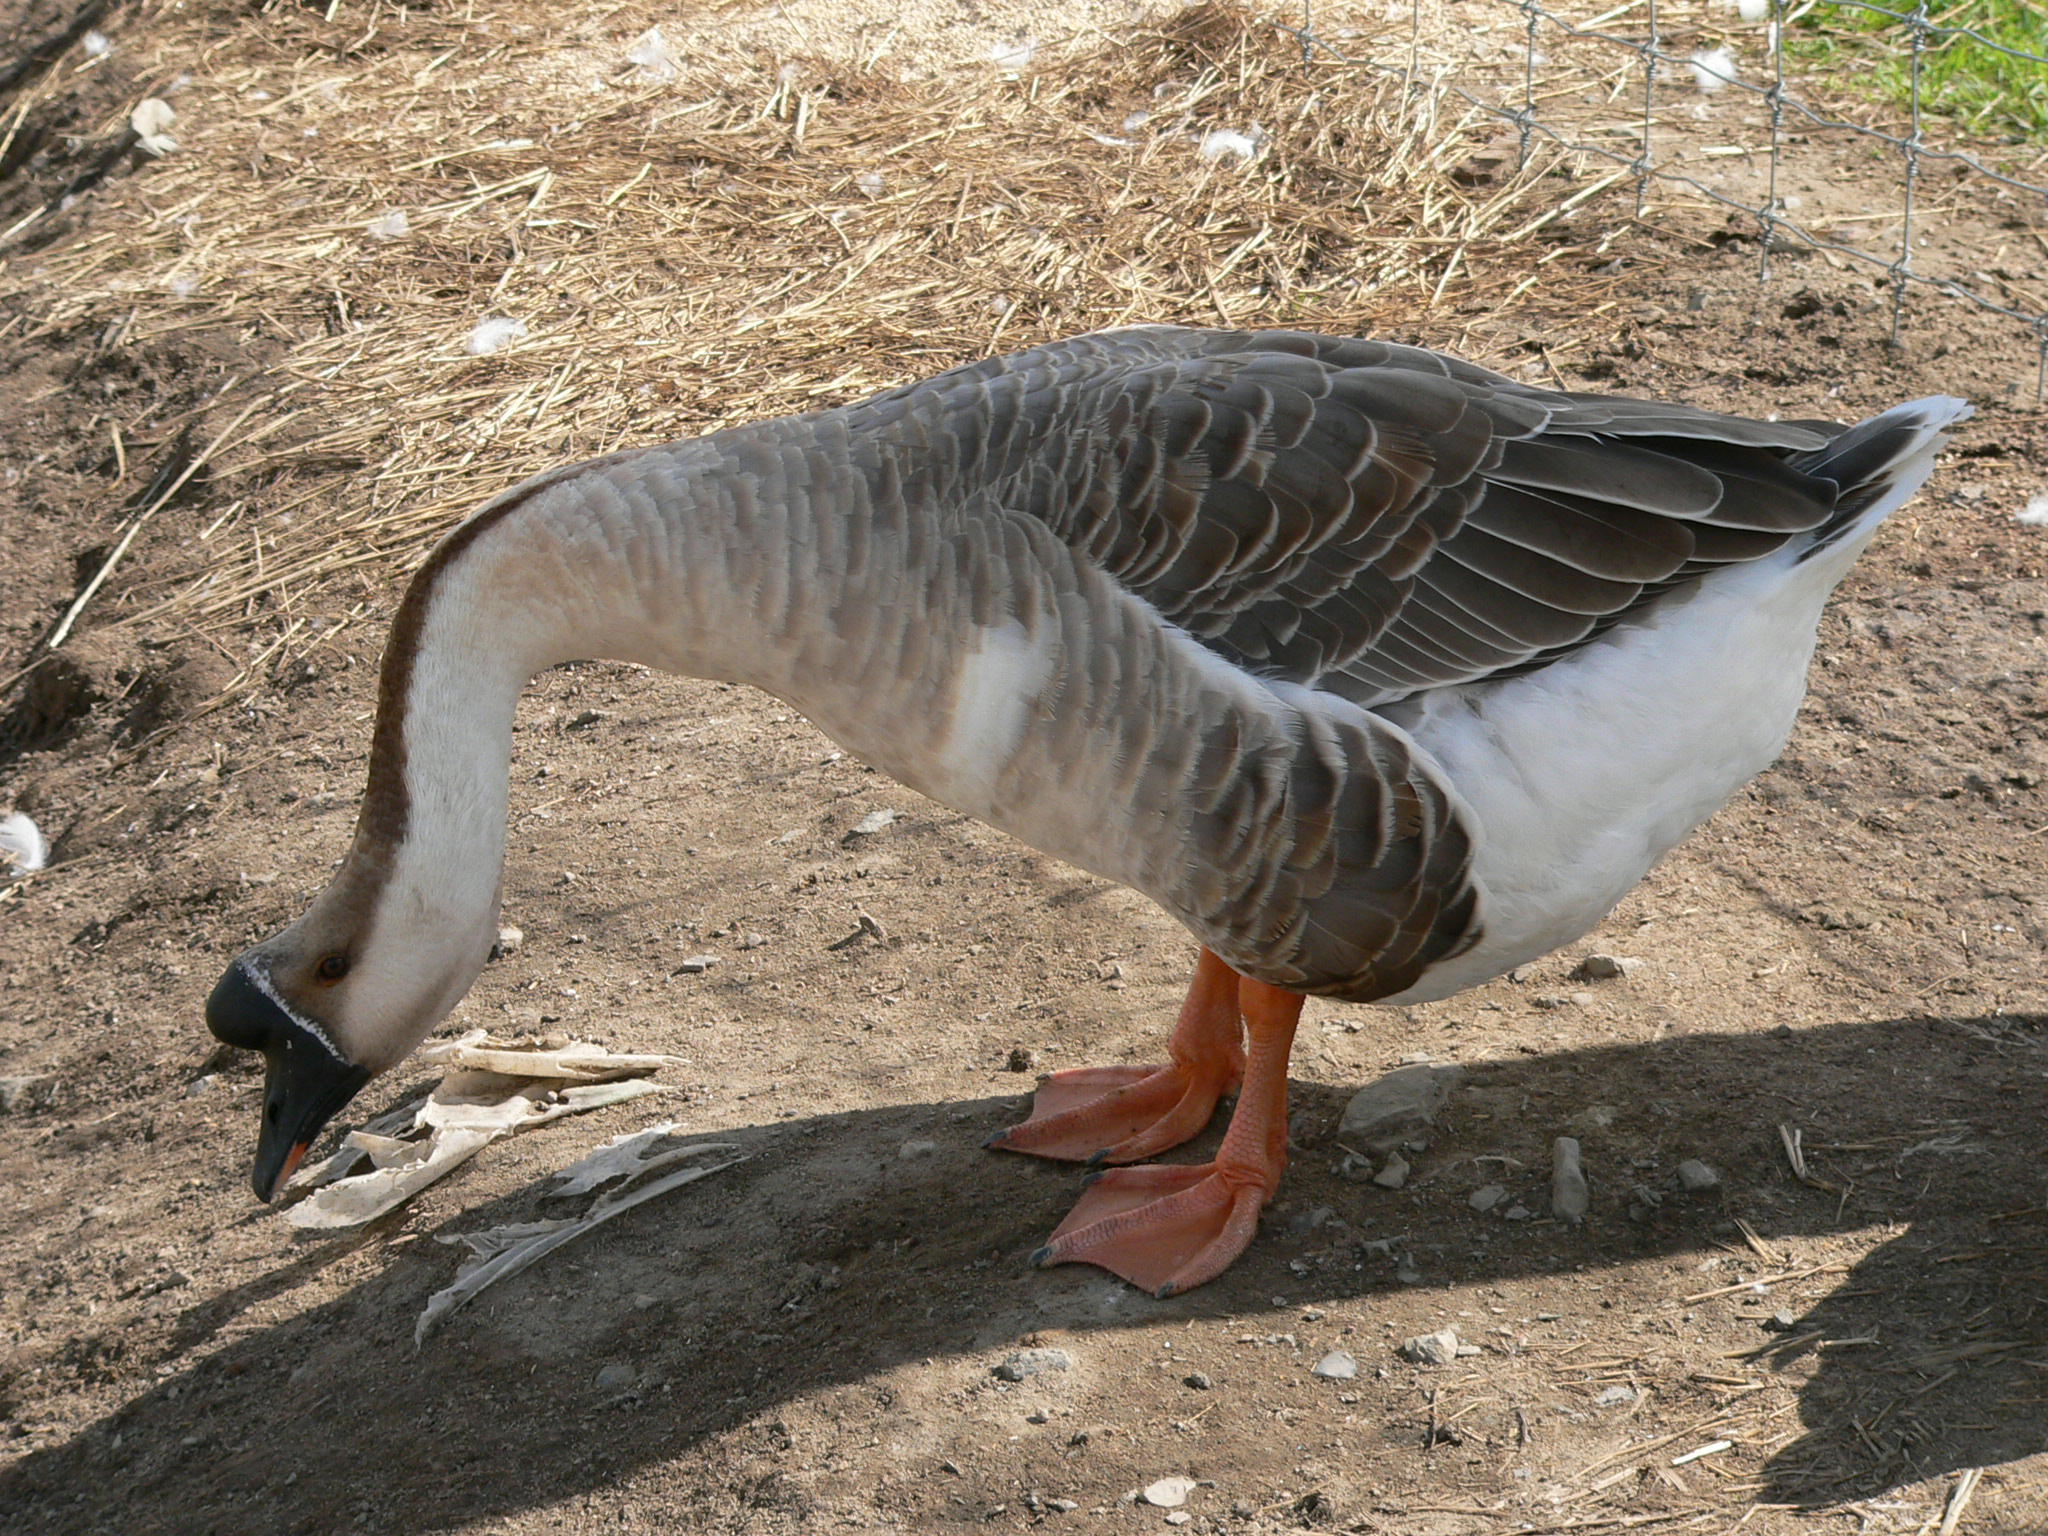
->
xmin=344 ymin=449 xmax=645 ymax=909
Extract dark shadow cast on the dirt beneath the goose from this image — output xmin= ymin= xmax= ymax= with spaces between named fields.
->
xmin=0 ymin=1016 xmax=2048 ymax=1536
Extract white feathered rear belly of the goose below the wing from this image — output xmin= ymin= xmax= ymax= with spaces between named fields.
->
xmin=1382 ymin=532 xmax=1876 ymax=1004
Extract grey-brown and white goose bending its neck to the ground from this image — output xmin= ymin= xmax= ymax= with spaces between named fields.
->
xmin=207 ymin=326 xmax=1970 ymax=1296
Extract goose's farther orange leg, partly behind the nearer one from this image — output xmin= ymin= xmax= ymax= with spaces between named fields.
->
xmin=987 ymin=950 xmax=1245 ymax=1163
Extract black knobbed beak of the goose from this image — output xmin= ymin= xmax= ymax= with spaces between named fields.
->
xmin=207 ymin=961 xmax=371 ymax=1200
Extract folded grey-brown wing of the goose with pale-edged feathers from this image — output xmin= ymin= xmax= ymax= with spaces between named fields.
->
xmin=868 ymin=326 xmax=1841 ymax=705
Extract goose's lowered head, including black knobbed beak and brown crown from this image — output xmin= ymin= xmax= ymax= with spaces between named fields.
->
xmin=207 ymin=877 xmax=496 ymax=1200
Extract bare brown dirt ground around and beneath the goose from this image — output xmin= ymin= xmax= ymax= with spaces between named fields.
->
xmin=0 ymin=6 xmax=2048 ymax=1536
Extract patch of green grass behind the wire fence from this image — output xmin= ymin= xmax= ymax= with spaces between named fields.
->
xmin=1786 ymin=0 xmax=2048 ymax=143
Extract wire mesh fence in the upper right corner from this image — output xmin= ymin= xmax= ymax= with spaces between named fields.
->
xmin=1280 ymin=0 xmax=2048 ymax=403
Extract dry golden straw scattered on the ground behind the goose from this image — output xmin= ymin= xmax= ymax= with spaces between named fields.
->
xmin=0 ymin=0 xmax=1630 ymax=708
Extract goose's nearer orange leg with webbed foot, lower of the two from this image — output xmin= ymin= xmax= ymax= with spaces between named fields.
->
xmin=1032 ymin=977 xmax=1303 ymax=1296
